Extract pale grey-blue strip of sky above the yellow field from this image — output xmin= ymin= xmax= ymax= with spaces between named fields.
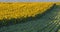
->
xmin=0 ymin=0 xmax=60 ymax=2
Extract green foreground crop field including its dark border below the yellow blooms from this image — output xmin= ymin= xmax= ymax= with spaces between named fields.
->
xmin=0 ymin=3 xmax=60 ymax=32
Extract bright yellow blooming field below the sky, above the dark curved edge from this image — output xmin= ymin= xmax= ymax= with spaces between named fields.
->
xmin=0 ymin=2 xmax=54 ymax=20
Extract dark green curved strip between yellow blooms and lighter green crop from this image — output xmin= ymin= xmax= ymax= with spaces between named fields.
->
xmin=0 ymin=4 xmax=56 ymax=26
